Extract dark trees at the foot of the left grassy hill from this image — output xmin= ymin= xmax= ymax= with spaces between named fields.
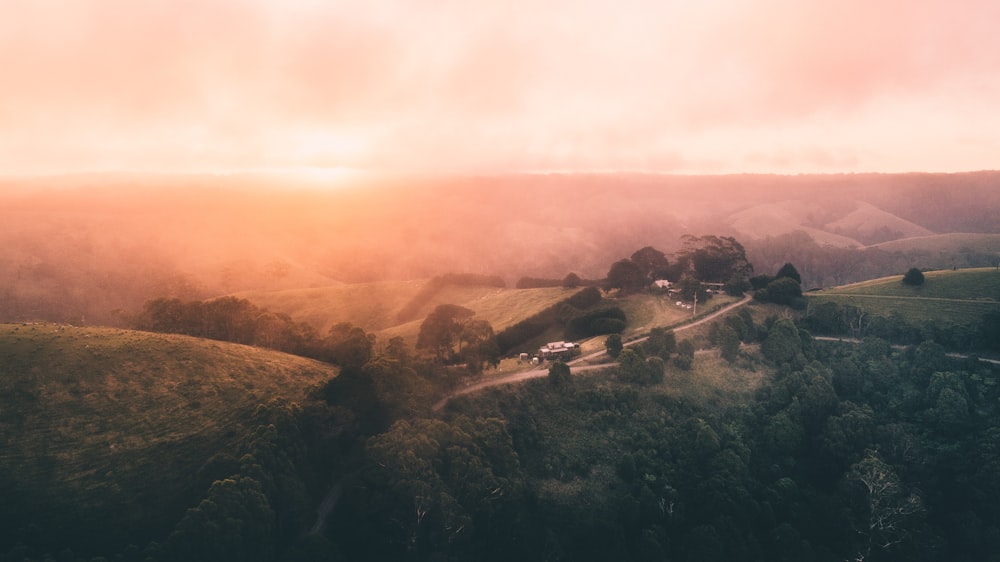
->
xmin=0 ymin=400 xmax=336 ymax=562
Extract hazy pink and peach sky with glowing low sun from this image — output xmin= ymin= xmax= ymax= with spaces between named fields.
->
xmin=0 ymin=0 xmax=1000 ymax=173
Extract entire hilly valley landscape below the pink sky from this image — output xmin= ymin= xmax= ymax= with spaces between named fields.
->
xmin=0 ymin=172 xmax=1000 ymax=562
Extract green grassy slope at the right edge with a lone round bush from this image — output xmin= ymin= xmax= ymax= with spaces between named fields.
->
xmin=807 ymin=268 xmax=1000 ymax=325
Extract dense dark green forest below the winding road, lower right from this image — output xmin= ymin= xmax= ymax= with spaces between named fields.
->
xmin=436 ymin=318 xmax=1000 ymax=562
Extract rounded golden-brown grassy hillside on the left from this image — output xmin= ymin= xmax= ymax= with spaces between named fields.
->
xmin=0 ymin=324 xmax=336 ymax=548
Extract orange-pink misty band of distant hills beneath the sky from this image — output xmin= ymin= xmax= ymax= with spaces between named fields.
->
xmin=0 ymin=172 xmax=1000 ymax=325
